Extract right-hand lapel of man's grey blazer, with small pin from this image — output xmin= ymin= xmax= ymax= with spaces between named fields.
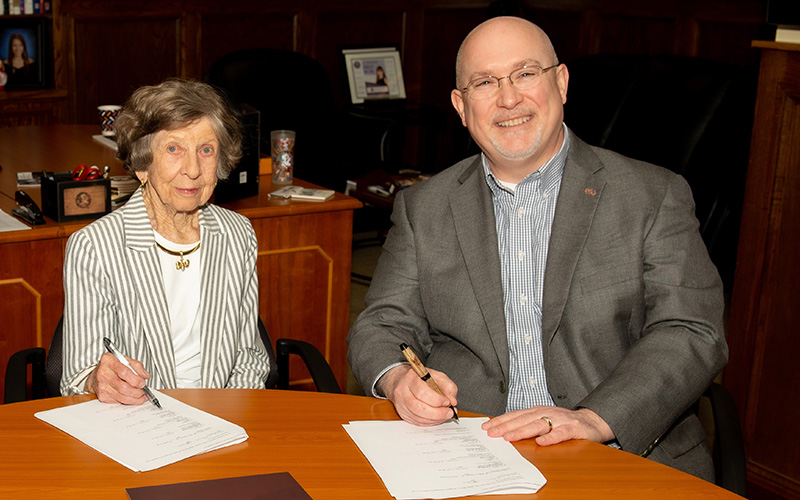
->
xmin=542 ymin=135 xmax=606 ymax=349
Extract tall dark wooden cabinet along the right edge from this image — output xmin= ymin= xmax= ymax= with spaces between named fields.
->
xmin=724 ymin=42 xmax=800 ymax=499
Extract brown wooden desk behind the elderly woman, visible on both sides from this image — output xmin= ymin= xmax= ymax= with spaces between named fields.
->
xmin=0 ymin=125 xmax=361 ymax=400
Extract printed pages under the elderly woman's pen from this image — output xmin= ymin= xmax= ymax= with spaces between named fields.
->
xmin=35 ymin=391 xmax=248 ymax=472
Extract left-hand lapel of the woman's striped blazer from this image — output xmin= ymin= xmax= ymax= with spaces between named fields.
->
xmin=123 ymin=189 xmax=176 ymax=387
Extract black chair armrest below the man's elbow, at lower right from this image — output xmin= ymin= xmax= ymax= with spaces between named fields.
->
xmin=703 ymin=382 xmax=747 ymax=498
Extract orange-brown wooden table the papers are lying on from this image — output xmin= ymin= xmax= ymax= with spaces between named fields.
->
xmin=0 ymin=389 xmax=741 ymax=500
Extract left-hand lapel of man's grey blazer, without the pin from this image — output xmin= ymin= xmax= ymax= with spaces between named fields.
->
xmin=449 ymin=156 xmax=509 ymax=376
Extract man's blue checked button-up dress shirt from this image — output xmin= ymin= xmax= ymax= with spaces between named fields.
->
xmin=483 ymin=125 xmax=570 ymax=411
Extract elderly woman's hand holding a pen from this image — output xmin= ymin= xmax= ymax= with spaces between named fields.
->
xmin=86 ymin=353 xmax=150 ymax=405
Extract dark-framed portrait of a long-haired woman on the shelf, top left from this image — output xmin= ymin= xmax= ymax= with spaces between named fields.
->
xmin=0 ymin=16 xmax=51 ymax=89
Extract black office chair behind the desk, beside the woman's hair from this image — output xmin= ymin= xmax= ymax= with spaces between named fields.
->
xmin=205 ymin=48 xmax=342 ymax=191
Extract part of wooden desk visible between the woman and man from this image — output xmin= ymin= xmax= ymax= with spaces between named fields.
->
xmin=223 ymin=182 xmax=361 ymax=388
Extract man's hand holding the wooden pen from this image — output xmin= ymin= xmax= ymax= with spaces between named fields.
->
xmin=377 ymin=364 xmax=458 ymax=426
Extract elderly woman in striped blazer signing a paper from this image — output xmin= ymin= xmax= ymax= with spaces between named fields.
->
xmin=61 ymin=80 xmax=269 ymax=404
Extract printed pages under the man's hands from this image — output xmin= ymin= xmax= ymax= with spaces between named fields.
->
xmin=343 ymin=417 xmax=547 ymax=500
